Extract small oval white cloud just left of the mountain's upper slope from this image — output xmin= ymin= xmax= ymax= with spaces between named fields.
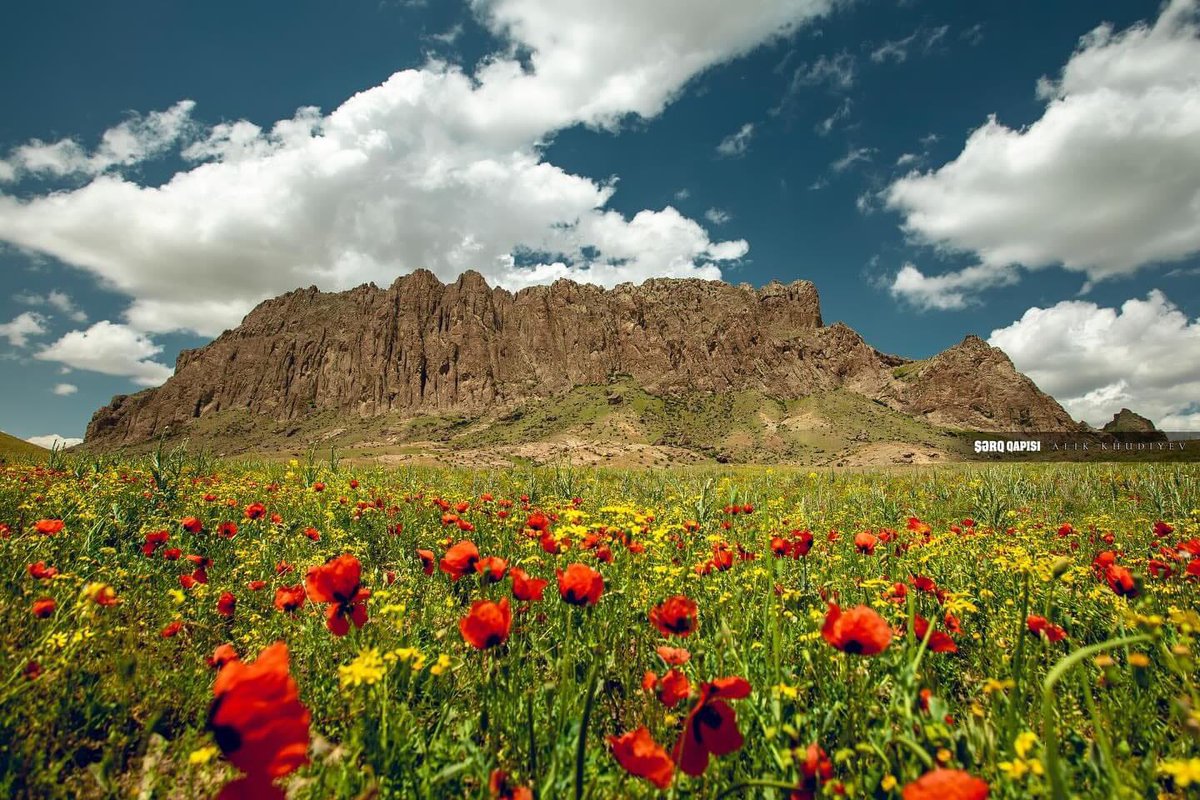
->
xmin=35 ymin=320 xmax=174 ymax=386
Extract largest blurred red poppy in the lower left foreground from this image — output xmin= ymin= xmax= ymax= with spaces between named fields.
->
xmin=208 ymin=642 xmax=310 ymax=796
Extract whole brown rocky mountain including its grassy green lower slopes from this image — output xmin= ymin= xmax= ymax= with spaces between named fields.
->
xmin=85 ymin=270 xmax=1078 ymax=463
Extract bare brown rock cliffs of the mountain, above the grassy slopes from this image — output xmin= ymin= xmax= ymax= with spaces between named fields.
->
xmin=86 ymin=270 xmax=1074 ymax=445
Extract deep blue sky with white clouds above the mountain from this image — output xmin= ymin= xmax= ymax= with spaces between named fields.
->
xmin=0 ymin=0 xmax=1200 ymax=443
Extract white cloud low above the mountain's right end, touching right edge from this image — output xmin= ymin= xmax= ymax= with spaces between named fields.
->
xmin=988 ymin=290 xmax=1200 ymax=431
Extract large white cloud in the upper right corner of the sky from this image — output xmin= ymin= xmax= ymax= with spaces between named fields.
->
xmin=887 ymin=0 xmax=1200 ymax=287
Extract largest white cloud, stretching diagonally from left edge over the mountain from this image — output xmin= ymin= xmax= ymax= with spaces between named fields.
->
xmin=0 ymin=0 xmax=836 ymax=335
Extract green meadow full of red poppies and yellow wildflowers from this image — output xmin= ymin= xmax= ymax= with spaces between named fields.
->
xmin=0 ymin=452 xmax=1200 ymax=800
